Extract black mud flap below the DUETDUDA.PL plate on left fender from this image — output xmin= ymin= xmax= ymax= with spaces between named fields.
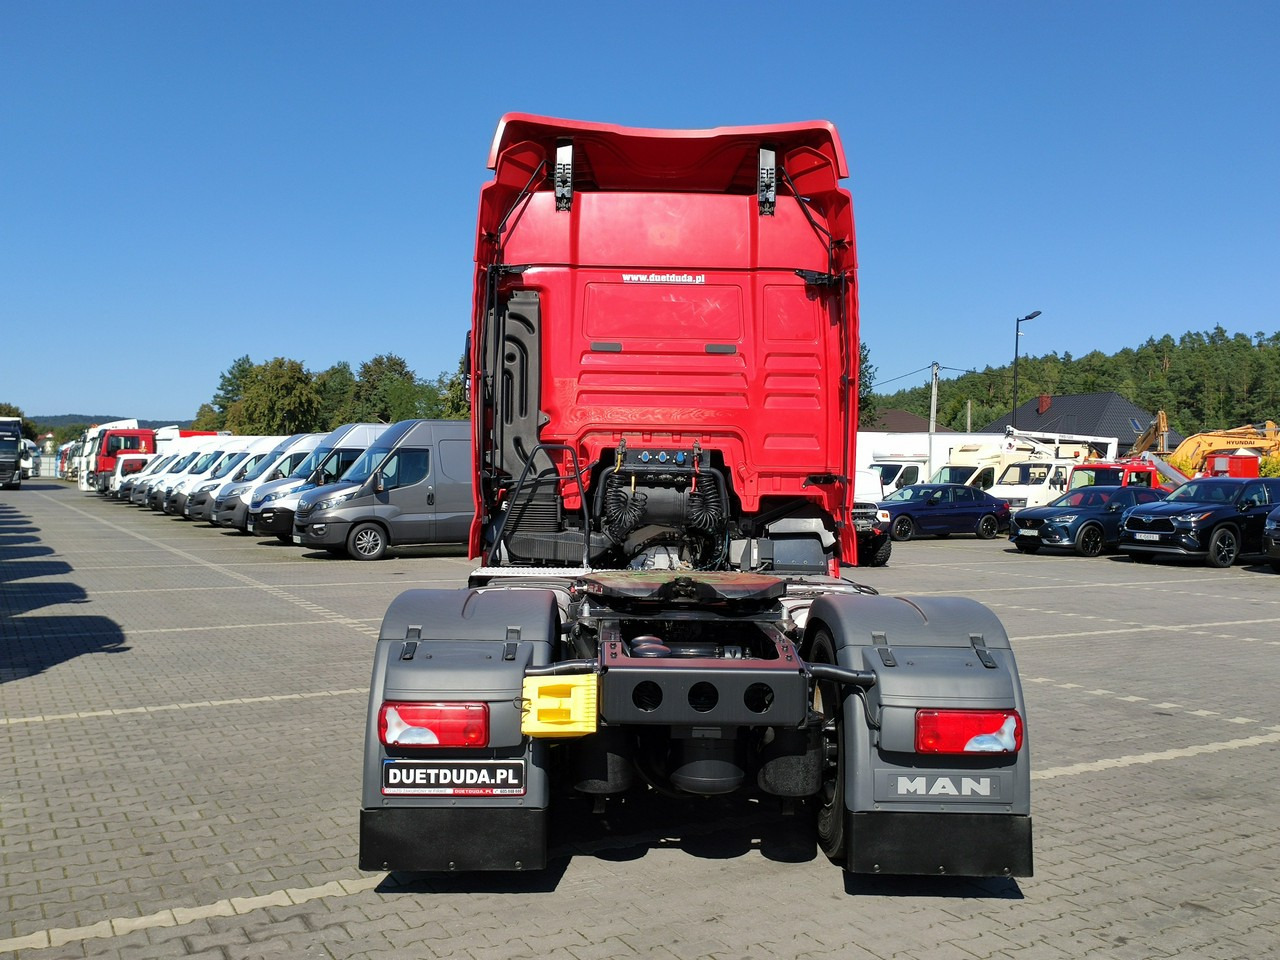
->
xmin=360 ymin=806 xmax=547 ymax=872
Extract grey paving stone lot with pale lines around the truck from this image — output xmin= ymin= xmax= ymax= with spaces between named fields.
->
xmin=0 ymin=480 xmax=1280 ymax=960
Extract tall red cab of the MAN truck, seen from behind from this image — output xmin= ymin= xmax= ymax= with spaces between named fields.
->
xmin=471 ymin=115 xmax=858 ymax=572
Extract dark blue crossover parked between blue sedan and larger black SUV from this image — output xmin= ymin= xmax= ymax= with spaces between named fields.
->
xmin=1009 ymin=485 xmax=1166 ymax=557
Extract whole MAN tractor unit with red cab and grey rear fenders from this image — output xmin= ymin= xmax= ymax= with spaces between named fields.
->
xmin=360 ymin=114 xmax=1032 ymax=876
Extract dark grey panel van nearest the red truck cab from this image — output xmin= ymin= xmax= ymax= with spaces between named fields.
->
xmin=293 ymin=420 xmax=475 ymax=559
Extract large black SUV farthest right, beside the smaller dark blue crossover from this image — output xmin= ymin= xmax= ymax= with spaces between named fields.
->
xmin=1120 ymin=476 xmax=1280 ymax=567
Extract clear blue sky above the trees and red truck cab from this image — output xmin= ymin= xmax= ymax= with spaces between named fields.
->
xmin=0 ymin=0 xmax=1280 ymax=420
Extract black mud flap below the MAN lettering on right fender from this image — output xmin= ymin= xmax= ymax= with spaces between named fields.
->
xmin=845 ymin=812 xmax=1032 ymax=877
